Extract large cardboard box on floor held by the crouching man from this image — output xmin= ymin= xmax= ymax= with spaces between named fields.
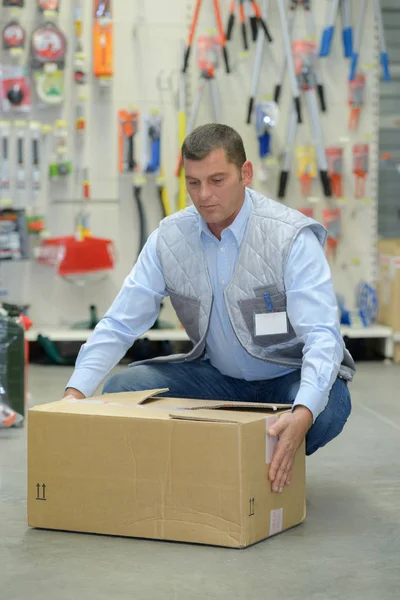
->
xmin=28 ymin=390 xmax=305 ymax=548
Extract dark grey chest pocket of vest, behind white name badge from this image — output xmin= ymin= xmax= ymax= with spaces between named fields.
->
xmin=239 ymin=289 xmax=296 ymax=348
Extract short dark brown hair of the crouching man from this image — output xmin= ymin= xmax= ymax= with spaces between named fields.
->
xmin=182 ymin=123 xmax=247 ymax=170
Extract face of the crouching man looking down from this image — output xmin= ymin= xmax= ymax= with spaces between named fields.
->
xmin=183 ymin=148 xmax=253 ymax=227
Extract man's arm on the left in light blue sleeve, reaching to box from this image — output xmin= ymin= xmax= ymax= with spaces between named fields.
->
xmin=65 ymin=230 xmax=167 ymax=398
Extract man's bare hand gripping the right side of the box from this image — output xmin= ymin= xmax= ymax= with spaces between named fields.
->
xmin=268 ymin=406 xmax=313 ymax=492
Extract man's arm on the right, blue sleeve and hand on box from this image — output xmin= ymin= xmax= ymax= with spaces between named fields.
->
xmin=269 ymin=229 xmax=344 ymax=491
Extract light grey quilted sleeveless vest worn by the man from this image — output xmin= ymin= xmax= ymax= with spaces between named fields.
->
xmin=136 ymin=189 xmax=355 ymax=380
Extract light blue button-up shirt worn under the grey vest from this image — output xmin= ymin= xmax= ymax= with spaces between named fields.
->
xmin=67 ymin=194 xmax=344 ymax=421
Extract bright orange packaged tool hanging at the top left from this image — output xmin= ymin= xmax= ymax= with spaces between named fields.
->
xmin=93 ymin=0 xmax=114 ymax=85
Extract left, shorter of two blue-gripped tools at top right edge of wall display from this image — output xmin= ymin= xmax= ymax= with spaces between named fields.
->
xmin=319 ymin=0 xmax=353 ymax=58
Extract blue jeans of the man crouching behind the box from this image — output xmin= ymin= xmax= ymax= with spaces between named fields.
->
xmin=103 ymin=360 xmax=351 ymax=455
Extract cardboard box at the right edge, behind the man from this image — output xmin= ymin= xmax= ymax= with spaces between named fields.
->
xmin=378 ymin=239 xmax=400 ymax=332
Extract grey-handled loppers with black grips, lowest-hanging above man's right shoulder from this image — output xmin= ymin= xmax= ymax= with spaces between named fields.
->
xmin=278 ymin=41 xmax=332 ymax=198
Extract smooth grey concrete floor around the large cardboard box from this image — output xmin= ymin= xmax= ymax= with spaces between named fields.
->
xmin=0 ymin=363 xmax=400 ymax=600
